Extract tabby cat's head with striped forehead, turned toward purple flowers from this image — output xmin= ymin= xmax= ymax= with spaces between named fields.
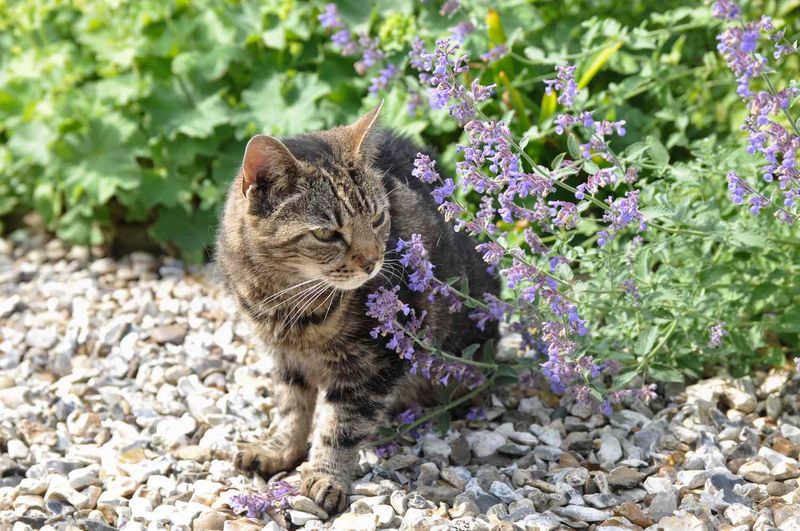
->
xmin=234 ymin=106 xmax=391 ymax=289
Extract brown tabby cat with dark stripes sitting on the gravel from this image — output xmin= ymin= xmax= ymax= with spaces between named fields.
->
xmin=216 ymin=106 xmax=498 ymax=514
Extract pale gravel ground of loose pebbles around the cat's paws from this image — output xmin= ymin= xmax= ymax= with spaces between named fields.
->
xmin=0 ymin=233 xmax=800 ymax=531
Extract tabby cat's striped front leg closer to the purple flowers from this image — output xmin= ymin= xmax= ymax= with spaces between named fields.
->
xmin=300 ymin=382 xmax=386 ymax=514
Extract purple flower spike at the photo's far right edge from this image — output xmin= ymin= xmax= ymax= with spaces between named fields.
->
xmin=713 ymin=0 xmax=800 ymax=223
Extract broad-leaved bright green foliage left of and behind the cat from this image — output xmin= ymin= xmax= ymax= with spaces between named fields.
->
xmin=0 ymin=0 xmax=363 ymax=260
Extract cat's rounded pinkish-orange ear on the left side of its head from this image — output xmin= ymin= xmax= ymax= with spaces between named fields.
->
xmin=242 ymin=135 xmax=300 ymax=197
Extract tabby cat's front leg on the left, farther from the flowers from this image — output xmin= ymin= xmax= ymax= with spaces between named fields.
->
xmin=235 ymin=366 xmax=317 ymax=478
